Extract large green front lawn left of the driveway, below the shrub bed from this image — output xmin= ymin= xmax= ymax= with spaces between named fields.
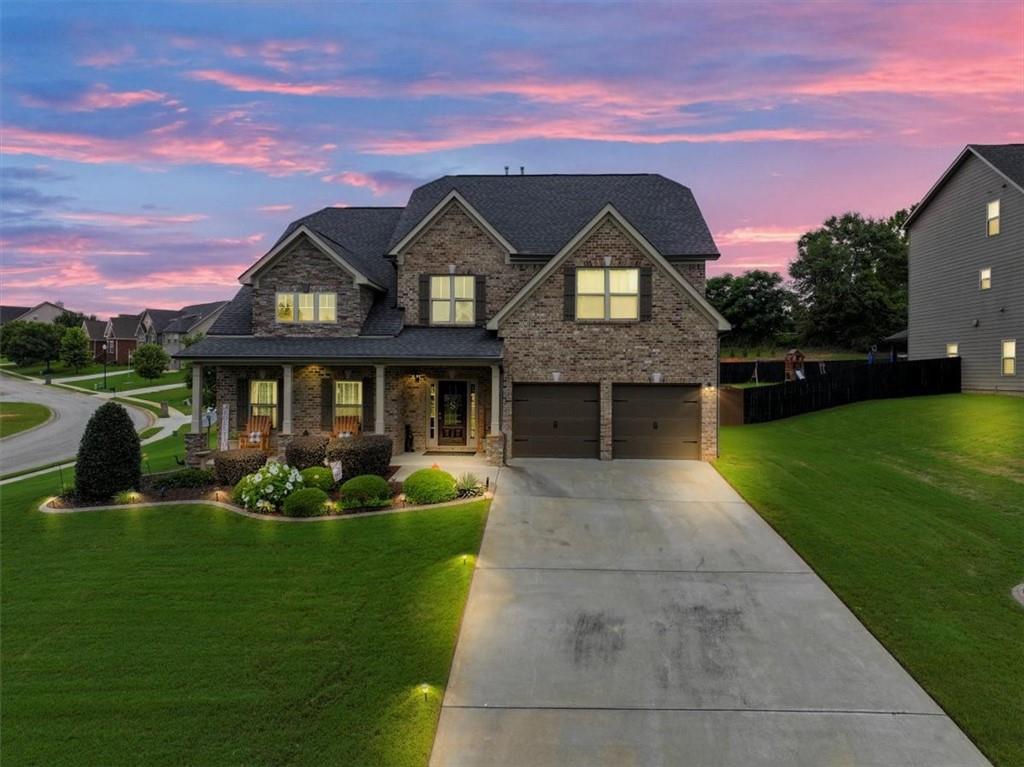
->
xmin=0 ymin=462 xmax=487 ymax=767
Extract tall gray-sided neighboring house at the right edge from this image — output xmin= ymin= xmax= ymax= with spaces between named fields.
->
xmin=905 ymin=143 xmax=1024 ymax=391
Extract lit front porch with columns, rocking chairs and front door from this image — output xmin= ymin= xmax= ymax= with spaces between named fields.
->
xmin=191 ymin=360 xmax=504 ymax=465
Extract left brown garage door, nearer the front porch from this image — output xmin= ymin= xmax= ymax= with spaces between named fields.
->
xmin=512 ymin=384 xmax=601 ymax=458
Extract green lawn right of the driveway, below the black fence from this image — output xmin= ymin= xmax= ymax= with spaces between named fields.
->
xmin=717 ymin=394 xmax=1024 ymax=766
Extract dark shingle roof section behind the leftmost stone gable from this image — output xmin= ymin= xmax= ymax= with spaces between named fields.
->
xmin=278 ymin=208 xmax=402 ymax=288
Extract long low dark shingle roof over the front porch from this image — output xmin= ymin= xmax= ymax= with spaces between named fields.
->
xmin=174 ymin=328 xmax=502 ymax=360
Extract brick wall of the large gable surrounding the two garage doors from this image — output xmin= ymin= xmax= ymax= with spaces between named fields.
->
xmin=499 ymin=211 xmax=718 ymax=460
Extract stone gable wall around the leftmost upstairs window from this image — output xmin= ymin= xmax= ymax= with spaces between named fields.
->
xmin=253 ymin=237 xmax=373 ymax=336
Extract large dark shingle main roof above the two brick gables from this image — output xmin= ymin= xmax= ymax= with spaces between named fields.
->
xmin=388 ymin=173 xmax=719 ymax=258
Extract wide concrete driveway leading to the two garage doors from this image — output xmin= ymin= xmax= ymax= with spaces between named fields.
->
xmin=430 ymin=460 xmax=988 ymax=767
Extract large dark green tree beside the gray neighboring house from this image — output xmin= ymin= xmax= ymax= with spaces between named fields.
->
xmin=790 ymin=210 xmax=909 ymax=349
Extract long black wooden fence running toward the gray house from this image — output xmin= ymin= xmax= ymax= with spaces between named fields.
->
xmin=720 ymin=357 xmax=961 ymax=426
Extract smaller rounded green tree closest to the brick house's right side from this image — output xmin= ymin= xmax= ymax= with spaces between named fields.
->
xmin=707 ymin=269 xmax=796 ymax=345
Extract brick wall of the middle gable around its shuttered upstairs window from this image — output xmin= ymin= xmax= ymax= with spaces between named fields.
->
xmin=397 ymin=202 xmax=540 ymax=325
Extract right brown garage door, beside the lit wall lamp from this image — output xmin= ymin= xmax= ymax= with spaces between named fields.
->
xmin=611 ymin=384 xmax=700 ymax=459
